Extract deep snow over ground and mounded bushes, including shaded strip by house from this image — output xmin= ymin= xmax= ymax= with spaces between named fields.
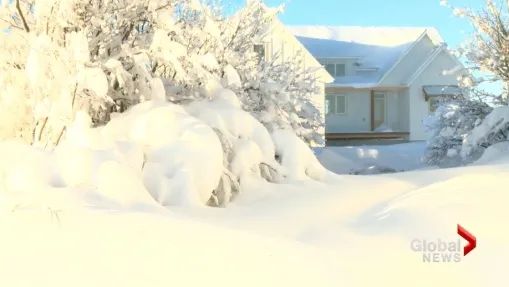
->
xmin=0 ymin=103 xmax=509 ymax=287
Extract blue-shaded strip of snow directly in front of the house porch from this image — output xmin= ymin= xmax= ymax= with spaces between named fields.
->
xmin=315 ymin=141 xmax=426 ymax=174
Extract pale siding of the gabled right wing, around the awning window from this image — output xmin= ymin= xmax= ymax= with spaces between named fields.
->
xmin=409 ymin=51 xmax=462 ymax=141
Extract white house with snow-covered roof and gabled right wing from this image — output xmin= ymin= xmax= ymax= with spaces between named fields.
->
xmin=290 ymin=26 xmax=466 ymax=142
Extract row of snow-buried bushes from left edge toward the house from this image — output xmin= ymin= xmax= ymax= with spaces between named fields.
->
xmin=0 ymin=99 xmax=326 ymax=207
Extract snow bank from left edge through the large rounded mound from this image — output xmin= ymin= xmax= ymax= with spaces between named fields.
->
xmin=0 ymin=102 xmax=223 ymax=209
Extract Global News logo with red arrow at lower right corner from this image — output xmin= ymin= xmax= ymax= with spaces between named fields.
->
xmin=410 ymin=224 xmax=477 ymax=263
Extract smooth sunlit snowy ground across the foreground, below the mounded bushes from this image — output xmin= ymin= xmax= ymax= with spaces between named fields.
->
xmin=0 ymin=143 xmax=509 ymax=287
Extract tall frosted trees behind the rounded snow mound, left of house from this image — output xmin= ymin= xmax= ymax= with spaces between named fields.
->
xmin=0 ymin=0 xmax=328 ymax=206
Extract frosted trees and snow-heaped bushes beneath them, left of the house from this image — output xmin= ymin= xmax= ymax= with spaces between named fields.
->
xmin=0 ymin=0 xmax=323 ymax=206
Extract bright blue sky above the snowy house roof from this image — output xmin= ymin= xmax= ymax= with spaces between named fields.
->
xmin=224 ymin=0 xmax=485 ymax=48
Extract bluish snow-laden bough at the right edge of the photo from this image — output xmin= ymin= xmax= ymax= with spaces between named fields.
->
xmin=461 ymin=106 xmax=509 ymax=158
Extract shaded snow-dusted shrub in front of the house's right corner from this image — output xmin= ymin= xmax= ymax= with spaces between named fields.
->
xmin=424 ymin=98 xmax=492 ymax=167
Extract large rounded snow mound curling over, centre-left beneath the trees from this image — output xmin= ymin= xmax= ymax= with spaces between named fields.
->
xmin=101 ymin=102 xmax=223 ymax=205
